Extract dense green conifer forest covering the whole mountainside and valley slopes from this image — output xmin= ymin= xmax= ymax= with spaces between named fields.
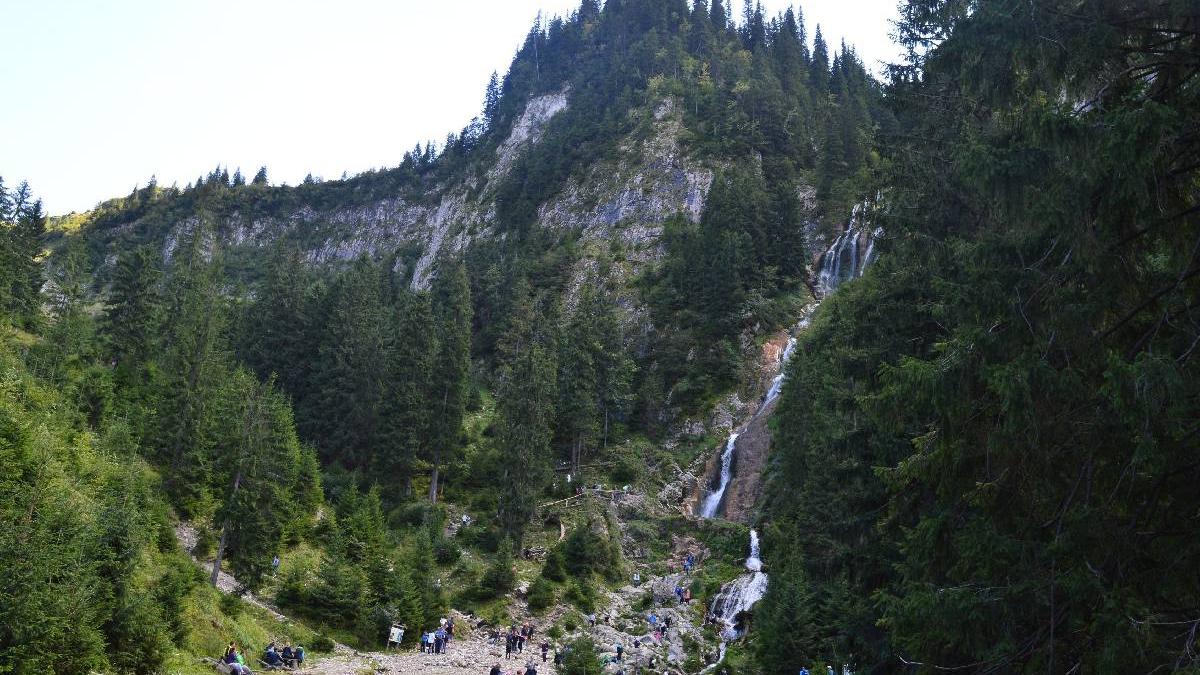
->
xmin=0 ymin=0 xmax=1200 ymax=675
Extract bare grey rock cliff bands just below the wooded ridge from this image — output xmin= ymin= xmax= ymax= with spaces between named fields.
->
xmin=131 ymin=90 xmax=729 ymax=288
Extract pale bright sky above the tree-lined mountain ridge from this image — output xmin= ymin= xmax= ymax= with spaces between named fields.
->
xmin=0 ymin=0 xmax=898 ymax=214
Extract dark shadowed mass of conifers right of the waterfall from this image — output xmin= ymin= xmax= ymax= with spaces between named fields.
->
xmin=756 ymin=0 xmax=1200 ymax=673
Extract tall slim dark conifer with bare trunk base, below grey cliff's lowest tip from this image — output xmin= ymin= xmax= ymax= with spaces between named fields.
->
xmin=428 ymin=261 xmax=470 ymax=502
